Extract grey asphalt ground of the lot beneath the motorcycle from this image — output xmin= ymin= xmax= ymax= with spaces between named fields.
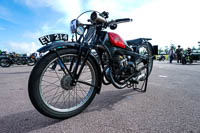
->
xmin=0 ymin=61 xmax=200 ymax=133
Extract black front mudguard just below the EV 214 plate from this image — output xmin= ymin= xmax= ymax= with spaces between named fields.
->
xmin=37 ymin=42 xmax=79 ymax=53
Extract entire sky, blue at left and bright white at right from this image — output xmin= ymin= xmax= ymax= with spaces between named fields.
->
xmin=0 ymin=0 xmax=200 ymax=53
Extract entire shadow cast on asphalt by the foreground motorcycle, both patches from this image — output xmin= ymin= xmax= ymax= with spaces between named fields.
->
xmin=0 ymin=89 xmax=144 ymax=133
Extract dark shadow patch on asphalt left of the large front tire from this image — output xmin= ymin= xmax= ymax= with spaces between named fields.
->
xmin=0 ymin=110 xmax=59 ymax=133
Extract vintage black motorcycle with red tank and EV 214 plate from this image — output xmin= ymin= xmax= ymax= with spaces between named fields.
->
xmin=28 ymin=11 xmax=154 ymax=119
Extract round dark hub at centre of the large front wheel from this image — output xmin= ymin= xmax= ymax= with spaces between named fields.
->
xmin=60 ymin=75 xmax=74 ymax=90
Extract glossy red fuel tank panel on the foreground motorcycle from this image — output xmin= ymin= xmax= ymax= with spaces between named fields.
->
xmin=108 ymin=32 xmax=130 ymax=49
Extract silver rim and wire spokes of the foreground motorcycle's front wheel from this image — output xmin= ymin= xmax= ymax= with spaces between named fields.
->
xmin=39 ymin=54 xmax=96 ymax=112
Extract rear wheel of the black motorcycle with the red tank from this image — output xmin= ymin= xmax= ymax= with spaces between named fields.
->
xmin=133 ymin=44 xmax=153 ymax=92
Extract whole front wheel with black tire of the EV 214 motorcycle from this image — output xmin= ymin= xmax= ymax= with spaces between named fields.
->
xmin=29 ymin=49 xmax=100 ymax=119
